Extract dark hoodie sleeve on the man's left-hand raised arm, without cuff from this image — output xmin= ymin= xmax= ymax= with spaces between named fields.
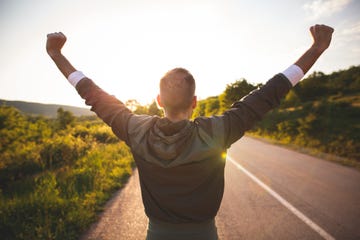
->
xmin=76 ymin=77 xmax=133 ymax=143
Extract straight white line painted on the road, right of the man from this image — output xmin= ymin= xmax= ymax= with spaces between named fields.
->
xmin=227 ymin=155 xmax=335 ymax=240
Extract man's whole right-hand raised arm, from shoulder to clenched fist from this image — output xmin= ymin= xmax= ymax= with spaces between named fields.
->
xmin=223 ymin=25 xmax=334 ymax=146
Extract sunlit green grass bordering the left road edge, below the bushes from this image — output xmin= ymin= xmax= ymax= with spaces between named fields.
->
xmin=0 ymin=144 xmax=133 ymax=239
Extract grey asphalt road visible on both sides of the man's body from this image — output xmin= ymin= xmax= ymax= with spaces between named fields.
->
xmin=81 ymin=137 xmax=360 ymax=240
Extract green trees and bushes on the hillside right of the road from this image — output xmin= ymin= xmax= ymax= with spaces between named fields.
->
xmin=194 ymin=66 xmax=360 ymax=170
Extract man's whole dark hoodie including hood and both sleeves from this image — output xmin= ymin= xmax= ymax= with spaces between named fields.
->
xmin=76 ymin=74 xmax=291 ymax=223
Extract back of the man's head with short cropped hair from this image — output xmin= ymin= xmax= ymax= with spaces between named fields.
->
xmin=160 ymin=68 xmax=195 ymax=115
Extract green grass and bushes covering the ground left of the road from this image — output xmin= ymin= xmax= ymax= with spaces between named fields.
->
xmin=0 ymin=106 xmax=134 ymax=240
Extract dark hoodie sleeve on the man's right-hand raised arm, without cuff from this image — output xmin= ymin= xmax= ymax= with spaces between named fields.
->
xmin=222 ymin=73 xmax=292 ymax=147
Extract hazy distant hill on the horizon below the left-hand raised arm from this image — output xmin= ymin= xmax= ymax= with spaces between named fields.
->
xmin=0 ymin=99 xmax=94 ymax=118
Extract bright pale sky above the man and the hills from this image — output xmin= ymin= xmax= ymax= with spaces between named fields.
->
xmin=0 ymin=0 xmax=360 ymax=107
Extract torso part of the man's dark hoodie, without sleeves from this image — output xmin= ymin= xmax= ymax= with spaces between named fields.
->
xmin=129 ymin=116 xmax=225 ymax=223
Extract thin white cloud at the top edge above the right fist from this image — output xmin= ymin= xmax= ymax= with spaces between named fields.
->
xmin=303 ymin=0 xmax=352 ymax=20
